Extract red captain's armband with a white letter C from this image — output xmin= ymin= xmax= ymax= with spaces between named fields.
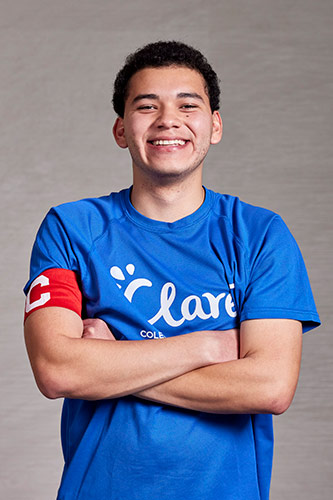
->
xmin=24 ymin=269 xmax=82 ymax=321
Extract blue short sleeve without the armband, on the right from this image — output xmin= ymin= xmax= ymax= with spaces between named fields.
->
xmin=240 ymin=216 xmax=320 ymax=332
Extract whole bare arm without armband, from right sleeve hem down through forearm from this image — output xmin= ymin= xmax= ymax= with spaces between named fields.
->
xmin=137 ymin=320 xmax=302 ymax=414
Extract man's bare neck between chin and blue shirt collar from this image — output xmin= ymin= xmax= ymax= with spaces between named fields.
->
xmin=131 ymin=176 xmax=205 ymax=222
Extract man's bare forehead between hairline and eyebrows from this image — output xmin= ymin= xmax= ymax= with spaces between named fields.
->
xmin=126 ymin=66 xmax=208 ymax=101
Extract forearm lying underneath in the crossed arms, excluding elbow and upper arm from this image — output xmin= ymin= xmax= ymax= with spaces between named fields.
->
xmin=136 ymin=358 xmax=278 ymax=414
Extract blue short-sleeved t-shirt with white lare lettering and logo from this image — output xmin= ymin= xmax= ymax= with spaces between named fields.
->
xmin=25 ymin=189 xmax=319 ymax=500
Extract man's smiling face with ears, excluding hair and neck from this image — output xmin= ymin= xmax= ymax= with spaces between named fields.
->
xmin=113 ymin=66 xmax=222 ymax=182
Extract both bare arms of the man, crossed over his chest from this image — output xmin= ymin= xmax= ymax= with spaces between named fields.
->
xmin=25 ymin=307 xmax=302 ymax=414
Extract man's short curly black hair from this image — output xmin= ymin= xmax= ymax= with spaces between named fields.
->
xmin=112 ymin=41 xmax=220 ymax=117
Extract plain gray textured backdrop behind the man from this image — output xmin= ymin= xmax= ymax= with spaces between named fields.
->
xmin=0 ymin=0 xmax=333 ymax=500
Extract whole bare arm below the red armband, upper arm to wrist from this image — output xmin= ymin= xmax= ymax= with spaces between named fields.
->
xmin=26 ymin=308 xmax=231 ymax=399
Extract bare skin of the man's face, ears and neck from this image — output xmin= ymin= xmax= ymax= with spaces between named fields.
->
xmin=113 ymin=67 xmax=222 ymax=222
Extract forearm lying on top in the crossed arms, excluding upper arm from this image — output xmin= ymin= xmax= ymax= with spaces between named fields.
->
xmin=45 ymin=337 xmax=208 ymax=399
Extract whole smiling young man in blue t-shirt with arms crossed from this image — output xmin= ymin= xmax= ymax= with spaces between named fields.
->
xmin=25 ymin=42 xmax=319 ymax=500
